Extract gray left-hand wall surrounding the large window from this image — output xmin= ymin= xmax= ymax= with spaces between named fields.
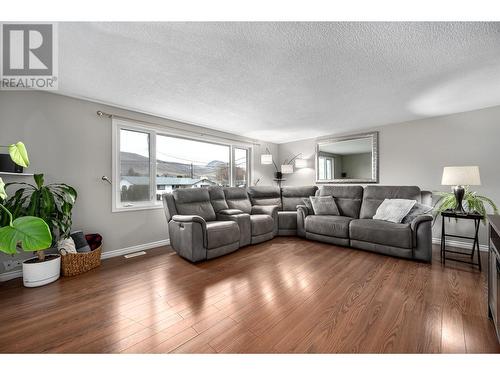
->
xmin=0 ymin=91 xmax=278 ymax=273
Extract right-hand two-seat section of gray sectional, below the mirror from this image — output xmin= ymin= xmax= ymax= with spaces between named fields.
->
xmin=298 ymin=185 xmax=433 ymax=261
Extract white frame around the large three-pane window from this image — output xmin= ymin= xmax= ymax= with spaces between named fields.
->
xmin=111 ymin=118 xmax=253 ymax=212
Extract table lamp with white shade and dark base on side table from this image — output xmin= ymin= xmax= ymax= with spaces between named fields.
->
xmin=441 ymin=166 xmax=481 ymax=213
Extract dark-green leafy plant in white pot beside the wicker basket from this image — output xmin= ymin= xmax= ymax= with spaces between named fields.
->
xmin=5 ymin=174 xmax=77 ymax=286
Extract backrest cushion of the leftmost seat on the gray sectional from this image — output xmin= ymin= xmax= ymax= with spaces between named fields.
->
xmin=172 ymin=188 xmax=216 ymax=221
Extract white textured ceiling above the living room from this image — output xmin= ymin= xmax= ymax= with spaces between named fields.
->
xmin=59 ymin=22 xmax=500 ymax=143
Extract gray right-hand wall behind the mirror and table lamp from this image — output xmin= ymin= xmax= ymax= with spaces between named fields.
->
xmin=279 ymin=106 xmax=500 ymax=244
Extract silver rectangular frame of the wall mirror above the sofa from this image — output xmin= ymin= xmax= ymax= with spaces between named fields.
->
xmin=314 ymin=131 xmax=379 ymax=184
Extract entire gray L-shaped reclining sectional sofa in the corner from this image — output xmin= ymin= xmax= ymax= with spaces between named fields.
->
xmin=163 ymin=185 xmax=433 ymax=262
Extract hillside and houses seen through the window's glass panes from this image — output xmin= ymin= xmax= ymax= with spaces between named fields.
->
xmin=120 ymin=129 xmax=248 ymax=203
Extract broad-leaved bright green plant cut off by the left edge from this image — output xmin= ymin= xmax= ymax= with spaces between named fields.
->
xmin=0 ymin=142 xmax=53 ymax=282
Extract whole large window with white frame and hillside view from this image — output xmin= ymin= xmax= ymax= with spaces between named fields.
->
xmin=113 ymin=119 xmax=251 ymax=212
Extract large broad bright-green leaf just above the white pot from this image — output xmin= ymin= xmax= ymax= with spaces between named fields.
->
xmin=0 ymin=216 xmax=52 ymax=254
